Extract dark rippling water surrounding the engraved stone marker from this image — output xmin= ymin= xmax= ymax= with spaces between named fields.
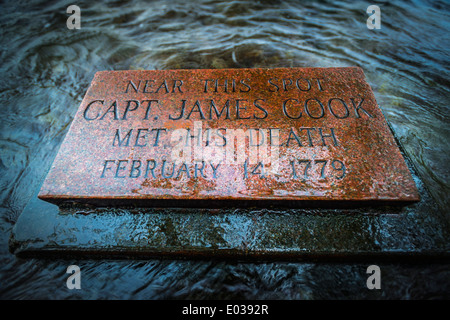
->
xmin=0 ymin=0 xmax=450 ymax=299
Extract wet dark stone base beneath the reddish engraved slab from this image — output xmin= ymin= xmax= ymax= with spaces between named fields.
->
xmin=10 ymin=150 xmax=450 ymax=262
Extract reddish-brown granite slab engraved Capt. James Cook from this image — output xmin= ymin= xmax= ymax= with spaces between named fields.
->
xmin=39 ymin=67 xmax=419 ymax=206
